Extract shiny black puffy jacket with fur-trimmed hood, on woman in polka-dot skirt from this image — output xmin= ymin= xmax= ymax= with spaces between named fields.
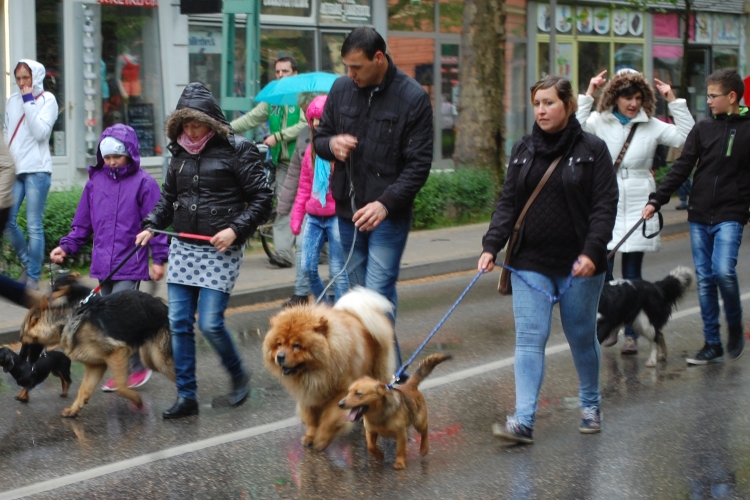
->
xmin=143 ymin=83 xmax=273 ymax=243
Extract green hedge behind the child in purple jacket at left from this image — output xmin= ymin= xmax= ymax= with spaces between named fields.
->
xmin=0 ymin=187 xmax=91 ymax=275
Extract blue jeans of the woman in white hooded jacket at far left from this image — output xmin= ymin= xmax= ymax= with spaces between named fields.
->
xmin=5 ymin=172 xmax=52 ymax=281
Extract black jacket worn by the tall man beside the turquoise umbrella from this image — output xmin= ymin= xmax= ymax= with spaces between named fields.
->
xmin=313 ymin=57 xmax=433 ymax=219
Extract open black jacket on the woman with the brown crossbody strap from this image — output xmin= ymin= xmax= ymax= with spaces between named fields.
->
xmin=482 ymin=132 xmax=618 ymax=273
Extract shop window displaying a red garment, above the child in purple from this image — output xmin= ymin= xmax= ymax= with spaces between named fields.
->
xmin=99 ymin=5 xmax=164 ymax=156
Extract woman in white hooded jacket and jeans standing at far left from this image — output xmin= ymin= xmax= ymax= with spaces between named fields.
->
xmin=3 ymin=59 xmax=58 ymax=290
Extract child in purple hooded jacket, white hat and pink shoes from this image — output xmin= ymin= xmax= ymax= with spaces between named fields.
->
xmin=50 ymin=124 xmax=169 ymax=392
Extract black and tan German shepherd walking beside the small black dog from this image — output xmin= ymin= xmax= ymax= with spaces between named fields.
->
xmin=21 ymin=286 xmax=175 ymax=417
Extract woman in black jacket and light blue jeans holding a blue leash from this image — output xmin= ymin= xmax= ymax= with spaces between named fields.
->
xmin=478 ymin=76 xmax=617 ymax=444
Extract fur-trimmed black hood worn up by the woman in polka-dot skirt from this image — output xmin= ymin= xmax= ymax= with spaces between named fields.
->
xmin=166 ymin=83 xmax=233 ymax=142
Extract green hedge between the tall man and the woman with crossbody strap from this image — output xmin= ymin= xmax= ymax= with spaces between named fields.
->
xmin=412 ymin=168 xmax=498 ymax=229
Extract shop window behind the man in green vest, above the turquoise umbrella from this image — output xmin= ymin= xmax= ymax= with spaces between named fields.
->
xmin=262 ymin=29 xmax=315 ymax=88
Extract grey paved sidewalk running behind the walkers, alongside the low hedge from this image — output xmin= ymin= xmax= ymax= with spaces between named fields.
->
xmin=0 ymin=203 xmax=688 ymax=344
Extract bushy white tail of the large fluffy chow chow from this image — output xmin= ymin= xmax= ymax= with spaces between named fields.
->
xmin=333 ymin=286 xmax=396 ymax=382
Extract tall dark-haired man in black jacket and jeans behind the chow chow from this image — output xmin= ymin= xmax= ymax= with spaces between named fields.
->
xmin=314 ymin=27 xmax=433 ymax=364
